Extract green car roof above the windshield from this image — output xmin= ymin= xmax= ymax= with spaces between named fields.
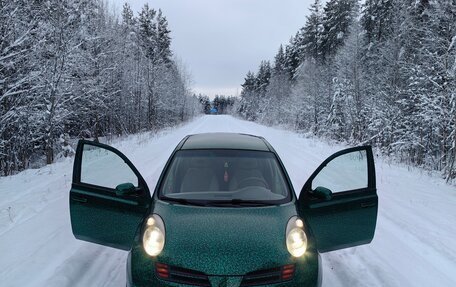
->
xmin=180 ymin=133 xmax=271 ymax=151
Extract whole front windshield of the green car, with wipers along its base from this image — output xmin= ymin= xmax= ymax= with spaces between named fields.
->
xmin=160 ymin=150 xmax=290 ymax=205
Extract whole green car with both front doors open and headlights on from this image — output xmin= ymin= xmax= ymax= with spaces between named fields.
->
xmin=69 ymin=133 xmax=378 ymax=287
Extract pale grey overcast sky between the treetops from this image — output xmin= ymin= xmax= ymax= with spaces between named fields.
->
xmin=111 ymin=0 xmax=314 ymax=97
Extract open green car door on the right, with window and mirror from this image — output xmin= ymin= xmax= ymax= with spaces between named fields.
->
xmin=299 ymin=146 xmax=378 ymax=252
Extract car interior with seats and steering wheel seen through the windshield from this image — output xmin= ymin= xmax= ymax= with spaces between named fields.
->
xmin=162 ymin=151 xmax=288 ymax=199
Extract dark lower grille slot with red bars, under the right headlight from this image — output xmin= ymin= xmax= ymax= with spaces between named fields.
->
xmin=241 ymin=264 xmax=295 ymax=287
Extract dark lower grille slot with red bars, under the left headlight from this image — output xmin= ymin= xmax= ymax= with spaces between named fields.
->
xmin=155 ymin=263 xmax=211 ymax=287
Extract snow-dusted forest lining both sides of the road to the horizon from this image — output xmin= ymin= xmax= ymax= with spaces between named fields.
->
xmin=0 ymin=0 xmax=456 ymax=181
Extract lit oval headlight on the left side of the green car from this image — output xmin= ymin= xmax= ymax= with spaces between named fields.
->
xmin=143 ymin=214 xmax=165 ymax=256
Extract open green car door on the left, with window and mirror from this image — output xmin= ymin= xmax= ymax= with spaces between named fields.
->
xmin=70 ymin=140 xmax=150 ymax=250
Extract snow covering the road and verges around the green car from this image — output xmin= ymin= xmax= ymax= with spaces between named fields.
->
xmin=0 ymin=116 xmax=456 ymax=287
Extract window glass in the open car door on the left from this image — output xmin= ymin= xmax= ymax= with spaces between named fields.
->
xmin=81 ymin=144 xmax=138 ymax=189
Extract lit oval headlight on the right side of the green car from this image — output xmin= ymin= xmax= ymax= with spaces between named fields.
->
xmin=286 ymin=216 xmax=307 ymax=257
